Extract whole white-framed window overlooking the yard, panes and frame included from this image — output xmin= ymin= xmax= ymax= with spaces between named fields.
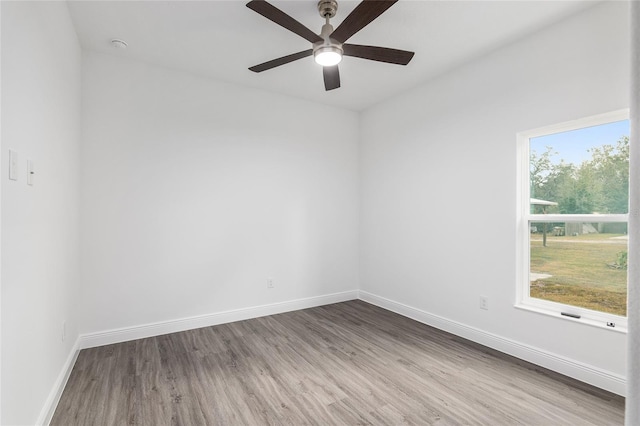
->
xmin=516 ymin=110 xmax=629 ymax=330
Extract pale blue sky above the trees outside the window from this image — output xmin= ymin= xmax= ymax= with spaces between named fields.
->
xmin=529 ymin=120 xmax=629 ymax=165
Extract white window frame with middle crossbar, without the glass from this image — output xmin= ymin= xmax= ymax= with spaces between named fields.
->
xmin=515 ymin=109 xmax=629 ymax=333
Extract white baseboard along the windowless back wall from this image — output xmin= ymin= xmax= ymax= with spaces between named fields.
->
xmin=79 ymin=290 xmax=358 ymax=349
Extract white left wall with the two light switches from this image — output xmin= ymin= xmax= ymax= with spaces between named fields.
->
xmin=0 ymin=2 xmax=81 ymax=425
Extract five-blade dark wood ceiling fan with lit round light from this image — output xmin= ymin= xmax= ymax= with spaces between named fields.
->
xmin=247 ymin=0 xmax=414 ymax=90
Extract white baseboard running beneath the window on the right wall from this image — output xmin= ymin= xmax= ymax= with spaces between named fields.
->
xmin=359 ymin=291 xmax=627 ymax=396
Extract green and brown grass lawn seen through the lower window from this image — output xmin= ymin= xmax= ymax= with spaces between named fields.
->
xmin=530 ymin=234 xmax=627 ymax=316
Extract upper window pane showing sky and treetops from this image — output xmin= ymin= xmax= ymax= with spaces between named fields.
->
xmin=529 ymin=120 xmax=629 ymax=214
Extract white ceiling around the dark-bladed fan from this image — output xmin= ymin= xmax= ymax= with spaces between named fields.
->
xmin=69 ymin=0 xmax=596 ymax=111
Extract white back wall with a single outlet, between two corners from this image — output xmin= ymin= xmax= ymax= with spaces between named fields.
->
xmin=81 ymin=52 xmax=359 ymax=333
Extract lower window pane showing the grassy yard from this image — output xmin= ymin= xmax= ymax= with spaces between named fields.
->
xmin=529 ymin=222 xmax=628 ymax=316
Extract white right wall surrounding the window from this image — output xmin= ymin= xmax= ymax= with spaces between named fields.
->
xmin=360 ymin=2 xmax=629 ymax=390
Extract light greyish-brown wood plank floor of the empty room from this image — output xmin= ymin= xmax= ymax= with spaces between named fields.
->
xmin=51 ymin=301 xmax=624 ymax=426
